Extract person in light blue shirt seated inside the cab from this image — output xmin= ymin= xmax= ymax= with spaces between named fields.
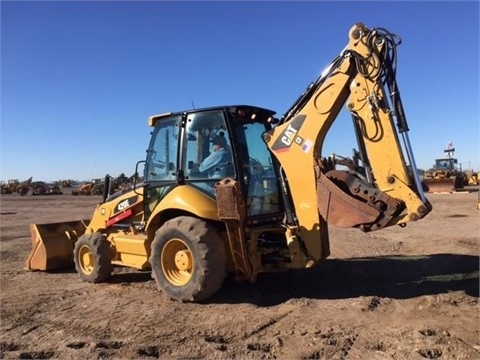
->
xmin=198 ymin=132 xmax=232 ymax=179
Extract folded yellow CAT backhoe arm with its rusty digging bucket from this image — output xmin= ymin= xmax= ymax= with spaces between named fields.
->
xmin=264 ymin=23 xmax=431 ymax=261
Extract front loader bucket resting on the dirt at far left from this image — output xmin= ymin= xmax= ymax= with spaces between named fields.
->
xmin=25 ymin=220 xmax=90 ymax=270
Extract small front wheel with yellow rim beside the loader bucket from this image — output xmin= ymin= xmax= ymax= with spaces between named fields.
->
xmin=73 ymin=233 xmax=113 ymax=283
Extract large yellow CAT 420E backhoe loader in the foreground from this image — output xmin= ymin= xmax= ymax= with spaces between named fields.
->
xmin=26 ymin=23 xmax=432 ymax=302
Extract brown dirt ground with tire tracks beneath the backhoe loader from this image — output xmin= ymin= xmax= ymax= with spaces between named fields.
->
xmin=0 ymin=192 xmax=480 ymax=359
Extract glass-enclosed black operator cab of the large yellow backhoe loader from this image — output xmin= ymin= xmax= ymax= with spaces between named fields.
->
xmin=144 ymin=106 xmax=281 ymax=221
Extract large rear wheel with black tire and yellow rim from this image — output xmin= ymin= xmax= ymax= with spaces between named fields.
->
xmin=150 ymin=216 xmax=226 ymax=302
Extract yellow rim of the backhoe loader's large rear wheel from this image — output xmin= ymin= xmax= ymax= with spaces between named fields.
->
xmin=161 ymin=239 xmax=194 ymax=286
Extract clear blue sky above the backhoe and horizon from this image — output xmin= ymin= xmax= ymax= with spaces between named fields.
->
xmin=0 ymin=1 xmax=480 ymax=181
